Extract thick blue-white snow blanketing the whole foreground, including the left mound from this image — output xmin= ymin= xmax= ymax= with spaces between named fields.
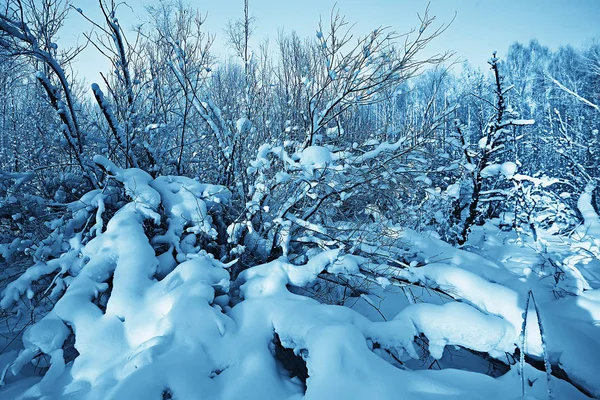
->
xmin=0 ymin=162 xmax=600 ymax=400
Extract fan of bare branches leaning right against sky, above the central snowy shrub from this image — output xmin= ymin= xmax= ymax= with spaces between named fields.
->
xmin=303 ymin=8 xmax=450 ymax=147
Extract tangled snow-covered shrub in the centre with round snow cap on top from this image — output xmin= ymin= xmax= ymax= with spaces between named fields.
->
xmin=228 ymin=133 xmax=448 ymax=270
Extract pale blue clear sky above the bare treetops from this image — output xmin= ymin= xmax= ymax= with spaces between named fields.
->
xmin=59 ymin=0 xmax=600 ymax=83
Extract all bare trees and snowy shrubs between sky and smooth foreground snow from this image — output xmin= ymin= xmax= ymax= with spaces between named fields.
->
xmin=0 ymin=0 xmax=600 ymax=400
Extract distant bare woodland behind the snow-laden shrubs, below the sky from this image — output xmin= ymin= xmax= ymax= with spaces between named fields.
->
xmin=0 ymin=2 xmax=600 ymax=247
